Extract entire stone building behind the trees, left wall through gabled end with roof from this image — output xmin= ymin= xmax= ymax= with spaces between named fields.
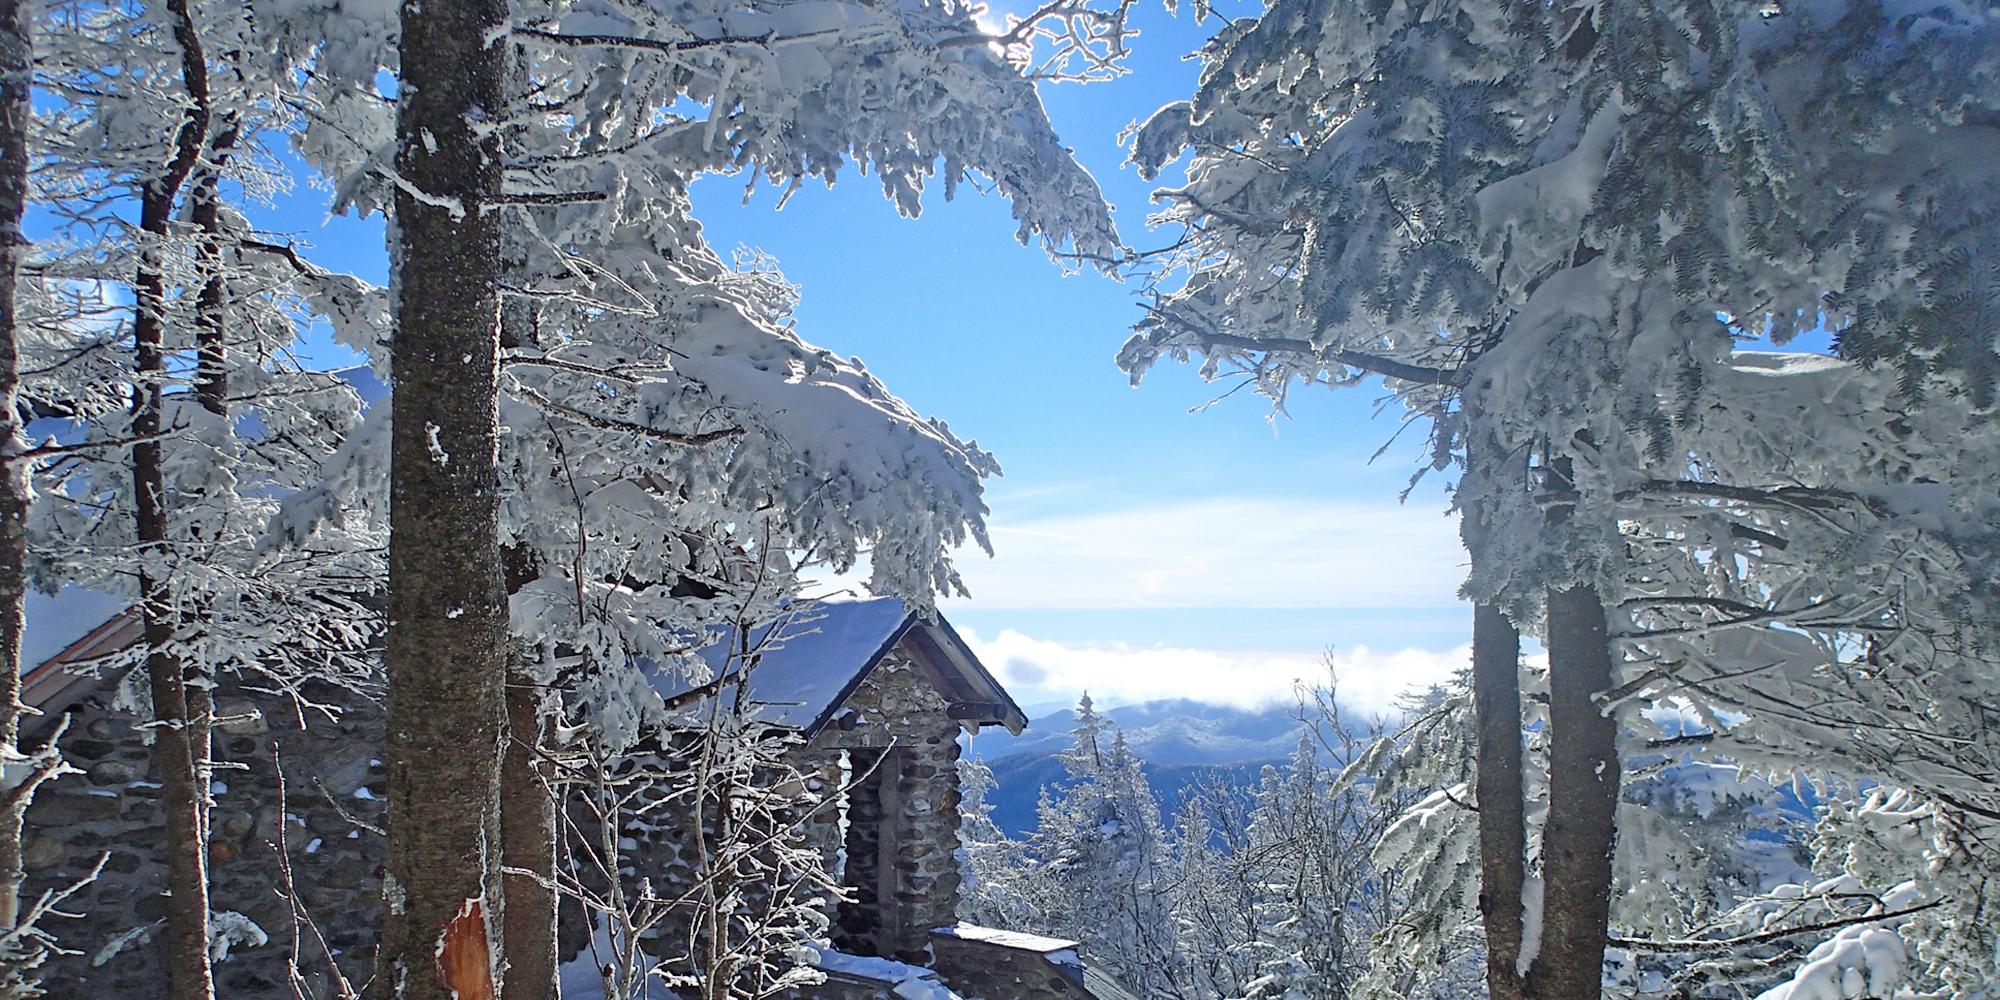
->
xmin=24 ymin=598 xmax=1128 ymax=1000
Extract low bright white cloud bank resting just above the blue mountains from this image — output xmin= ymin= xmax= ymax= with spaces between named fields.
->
xmin=964 ymin=630 xmax=1472 ymax=714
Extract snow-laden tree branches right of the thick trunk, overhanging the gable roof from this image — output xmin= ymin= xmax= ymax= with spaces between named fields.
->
xmin=238 ymin=2 xmax=1122 ymax=992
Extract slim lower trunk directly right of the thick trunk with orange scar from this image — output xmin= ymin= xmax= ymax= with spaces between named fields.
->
xmin=500 ymin=672 xmax=556 ymax=1000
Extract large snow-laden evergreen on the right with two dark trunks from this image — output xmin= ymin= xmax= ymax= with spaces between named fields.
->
xmin=1124 ymin=0 xmax=1996 ymax=996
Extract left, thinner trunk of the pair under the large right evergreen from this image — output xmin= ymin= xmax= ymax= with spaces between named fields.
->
xmin=1472 ymin=602 xmax=1528 ymax=1000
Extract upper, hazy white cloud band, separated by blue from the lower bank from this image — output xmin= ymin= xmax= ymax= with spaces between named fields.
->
xmin=948 ymin=498 xmax=1466 ymax=610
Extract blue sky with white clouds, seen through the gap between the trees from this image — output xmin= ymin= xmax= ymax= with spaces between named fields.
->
xmin=246 ymin=4 xmax=1470 ymax=706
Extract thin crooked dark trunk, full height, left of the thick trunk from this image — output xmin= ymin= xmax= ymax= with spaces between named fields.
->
xmin=132 ymin=0 xmax=214 ymax=1000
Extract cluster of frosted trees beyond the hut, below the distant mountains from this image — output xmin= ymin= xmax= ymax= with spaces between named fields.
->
xmin=968 ymin=692 xmax=1432 ymax=1000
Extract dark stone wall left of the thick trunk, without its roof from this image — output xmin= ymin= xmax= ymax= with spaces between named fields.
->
xmin=24 ymin=668 xmax=382 ymax=1000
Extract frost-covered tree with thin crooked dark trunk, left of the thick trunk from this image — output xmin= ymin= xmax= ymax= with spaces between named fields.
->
xmin=18 ymin=2 xmax=388 ymax=996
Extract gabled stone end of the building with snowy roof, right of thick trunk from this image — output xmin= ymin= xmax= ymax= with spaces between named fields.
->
xmin=628 ymin=598 xmax=1116 ymax=1000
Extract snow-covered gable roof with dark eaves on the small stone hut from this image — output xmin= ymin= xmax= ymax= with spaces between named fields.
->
xmin=646 ymin=598 xmax=1028 ymax=738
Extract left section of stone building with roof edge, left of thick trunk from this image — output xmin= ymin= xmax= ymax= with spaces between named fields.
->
xmin=22 ymin=592 xmax=384 ymax=1000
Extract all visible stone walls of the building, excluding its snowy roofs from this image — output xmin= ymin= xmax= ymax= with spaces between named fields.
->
xmin=26 ymin=636 xmax=980 ymax=1000
